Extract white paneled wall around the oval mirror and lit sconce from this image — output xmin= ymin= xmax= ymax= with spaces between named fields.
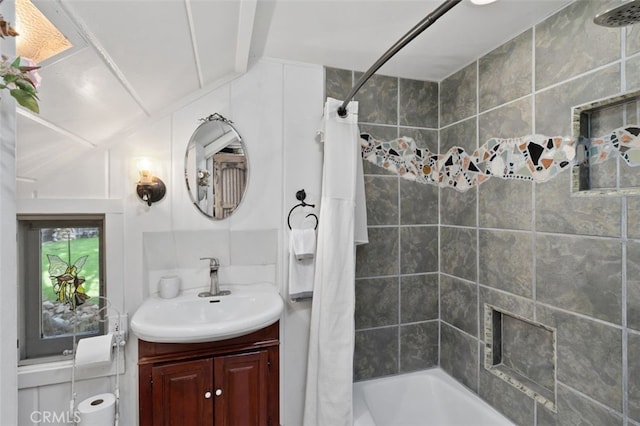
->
xmin=15 ymin=60 xmax=324 ymax=426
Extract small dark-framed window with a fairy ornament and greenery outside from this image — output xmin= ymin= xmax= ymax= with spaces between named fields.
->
xmin=18 ymin=215 xmax=106 ymax=364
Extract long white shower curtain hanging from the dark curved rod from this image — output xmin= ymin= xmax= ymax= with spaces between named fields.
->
xmin=304 ymin=98 xmax=367 ymax=426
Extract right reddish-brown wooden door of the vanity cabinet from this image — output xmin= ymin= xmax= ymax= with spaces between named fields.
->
xmin=214 ymin=351 xmax=270 ymax=426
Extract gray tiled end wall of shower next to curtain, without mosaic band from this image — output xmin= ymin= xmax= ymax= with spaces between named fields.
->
xmin=325 ymin=68 xmax=440 ymax=380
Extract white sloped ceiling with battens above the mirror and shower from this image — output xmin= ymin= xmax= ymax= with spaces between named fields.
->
xmin=11 ymin=0 xmax=571 ymax=180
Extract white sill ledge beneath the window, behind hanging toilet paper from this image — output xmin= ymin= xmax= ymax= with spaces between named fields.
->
xmin=18 ymin=351 xmax=125 ymax=389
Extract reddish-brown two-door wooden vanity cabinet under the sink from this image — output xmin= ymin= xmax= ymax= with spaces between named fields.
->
xmin=138 ymin=323 xmax=280 ymax=426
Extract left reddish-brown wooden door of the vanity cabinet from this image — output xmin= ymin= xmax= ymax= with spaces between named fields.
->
xmin=151 ymin=358 xmax=213 ymax=426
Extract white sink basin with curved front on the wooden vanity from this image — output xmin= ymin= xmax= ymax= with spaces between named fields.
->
xmin=131 ymin=283 xmax=283 ymax=343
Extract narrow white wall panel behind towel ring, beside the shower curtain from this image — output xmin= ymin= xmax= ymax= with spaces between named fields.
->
xmin=280 ymin=67 xmax=324 ymax=426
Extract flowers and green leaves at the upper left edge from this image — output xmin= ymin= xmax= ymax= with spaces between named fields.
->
xmin=0 ymin=15 xmax=40 ymax=113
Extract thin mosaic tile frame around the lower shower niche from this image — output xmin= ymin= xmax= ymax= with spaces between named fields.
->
xmin=484 ymin=303 xmax=558 ymax=413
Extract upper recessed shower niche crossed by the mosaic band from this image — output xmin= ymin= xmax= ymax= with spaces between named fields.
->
xmin=571 ymin=91 xmax=640 ymax=195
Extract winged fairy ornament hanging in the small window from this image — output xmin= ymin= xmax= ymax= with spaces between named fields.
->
xmin=47 ymin=254 xmax=89 ymax=310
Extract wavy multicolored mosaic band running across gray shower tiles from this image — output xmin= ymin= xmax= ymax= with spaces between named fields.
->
xmin=361 ymin=125 xmax=640 ymax=192
